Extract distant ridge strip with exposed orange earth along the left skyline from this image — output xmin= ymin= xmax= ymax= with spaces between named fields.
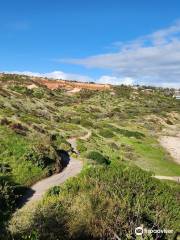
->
xmin=0 ymin=73 xmax=111 ymax=91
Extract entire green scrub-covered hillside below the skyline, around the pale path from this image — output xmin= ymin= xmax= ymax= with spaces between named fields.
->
xmin=0 ymin=74 xmax=180 ymax=240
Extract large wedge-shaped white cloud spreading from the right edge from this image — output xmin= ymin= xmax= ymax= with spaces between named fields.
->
xmin=61 ymin=22 xmax=180 ymax=87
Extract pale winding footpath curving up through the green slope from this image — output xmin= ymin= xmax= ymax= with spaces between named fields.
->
xmin=20 ymin=129 xmax=91 ymax=207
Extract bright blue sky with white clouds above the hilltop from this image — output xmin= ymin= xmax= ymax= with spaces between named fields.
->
xmin=0 ymin=0 xmax=180 ymax=87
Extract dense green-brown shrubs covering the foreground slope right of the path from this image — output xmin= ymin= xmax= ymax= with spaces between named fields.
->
xmin=10 ymin=164 xmax=180 ymax=239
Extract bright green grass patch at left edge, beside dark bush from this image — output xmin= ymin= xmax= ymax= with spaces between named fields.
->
xmin=0 ymin=126 xmax=45 ymax=185
